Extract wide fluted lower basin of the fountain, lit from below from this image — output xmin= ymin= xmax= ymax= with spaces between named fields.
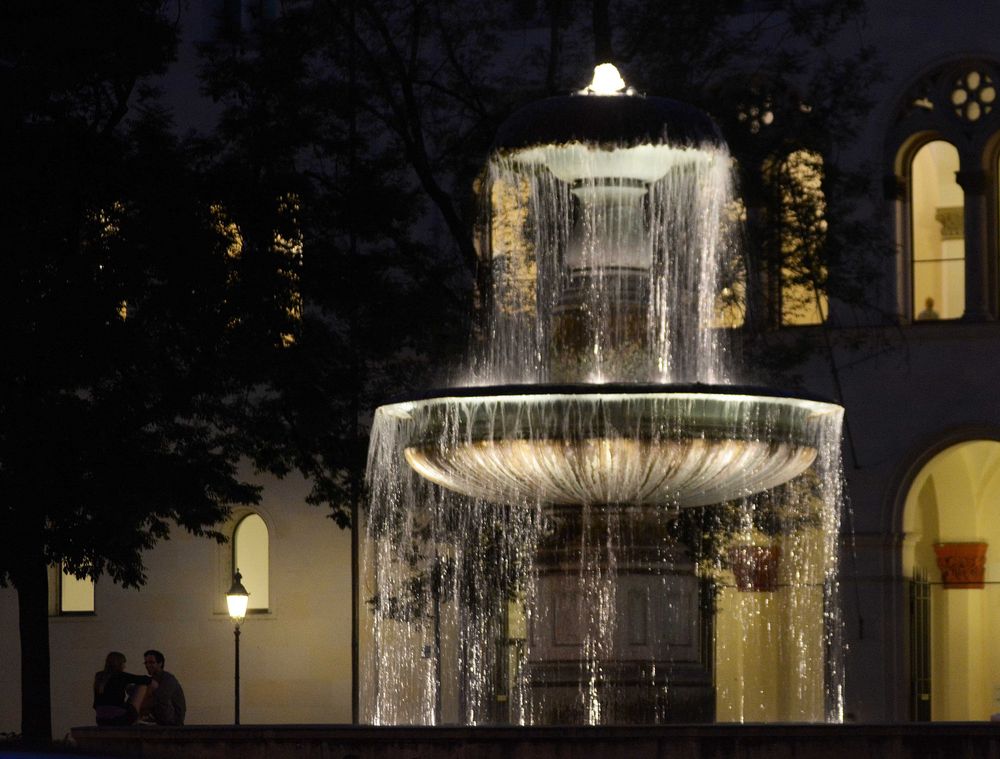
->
xmin=379 ymin=385 xmax=842 ymax=507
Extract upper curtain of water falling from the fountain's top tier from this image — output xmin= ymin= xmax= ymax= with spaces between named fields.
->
xmin=467 ymin=146 xmax=735 ymax=385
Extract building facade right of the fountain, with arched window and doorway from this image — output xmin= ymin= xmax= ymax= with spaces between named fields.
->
xmin=796 ymin=2 xmax=1000 ymax=722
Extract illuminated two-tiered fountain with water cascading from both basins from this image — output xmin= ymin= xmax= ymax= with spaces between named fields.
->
xmin=360 ymin=68 xmax=842 ymax=724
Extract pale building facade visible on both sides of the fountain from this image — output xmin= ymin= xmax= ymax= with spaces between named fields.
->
xmin=0 ymin=0 xmax=1000 ymax=737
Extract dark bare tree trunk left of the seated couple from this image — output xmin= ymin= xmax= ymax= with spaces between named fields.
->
xmin=12 ymin=550 xmax=53 ymax=745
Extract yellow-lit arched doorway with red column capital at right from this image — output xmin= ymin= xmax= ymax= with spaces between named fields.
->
xmin=902 ymin=440 xmax=1000 ymax=721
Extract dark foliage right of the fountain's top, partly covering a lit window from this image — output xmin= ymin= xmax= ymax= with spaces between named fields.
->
xmin=616 ymin=0 xmax=894 ymax=383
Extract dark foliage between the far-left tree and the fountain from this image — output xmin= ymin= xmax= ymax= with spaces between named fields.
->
xmin=194 ymin=0 xmax=504 ymax=526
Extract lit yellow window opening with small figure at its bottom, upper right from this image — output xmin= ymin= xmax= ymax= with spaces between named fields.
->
xmin=910 ymin=140 xmax=965 ymax=321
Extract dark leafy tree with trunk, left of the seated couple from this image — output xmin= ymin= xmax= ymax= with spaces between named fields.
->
xmin=0 ymin=0 xmax=288 ymax=741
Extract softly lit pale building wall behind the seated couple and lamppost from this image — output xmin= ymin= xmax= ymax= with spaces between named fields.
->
xmin=0 ymin=477 xmax=351 ymax=739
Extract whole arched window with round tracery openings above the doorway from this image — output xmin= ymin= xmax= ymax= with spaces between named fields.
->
xmin=889 ymin=60 xmax=1000 ymax=323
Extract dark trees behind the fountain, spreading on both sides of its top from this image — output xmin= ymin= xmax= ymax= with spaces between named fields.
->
xmin=191 ymin=0 xmax=888 ymax=525
